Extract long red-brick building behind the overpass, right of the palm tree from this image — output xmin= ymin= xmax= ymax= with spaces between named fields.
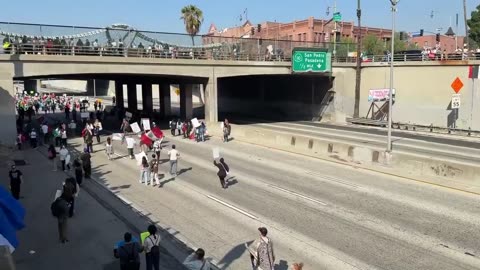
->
xmin=204 ymin=17 xmax=392 ymax=43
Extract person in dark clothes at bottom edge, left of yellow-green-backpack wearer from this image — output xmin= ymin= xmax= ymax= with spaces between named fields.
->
xmin=115 ymin=232 xmax=143 ymax=270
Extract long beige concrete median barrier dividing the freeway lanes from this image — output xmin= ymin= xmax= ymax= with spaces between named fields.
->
xmin=209 ymin=124 xmax=480 ymax=194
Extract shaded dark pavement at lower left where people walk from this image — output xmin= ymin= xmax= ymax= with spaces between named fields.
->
xmin=0 ymin=147 xmax=184 ymax=270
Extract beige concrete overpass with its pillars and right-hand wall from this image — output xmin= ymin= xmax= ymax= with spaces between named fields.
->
xmin=0 ymin=55 xmax=480 ymax=146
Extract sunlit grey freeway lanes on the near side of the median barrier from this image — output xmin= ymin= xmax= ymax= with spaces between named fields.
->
xmin=64 ymin=127 xmax=480 ymax=270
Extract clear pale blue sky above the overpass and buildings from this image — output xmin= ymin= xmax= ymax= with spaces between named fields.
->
xmin=1 ymin=0 xmax=480 ymax=34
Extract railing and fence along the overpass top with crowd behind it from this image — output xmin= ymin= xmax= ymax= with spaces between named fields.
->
xmin=0 ymin=22 xmax=480 ymax=63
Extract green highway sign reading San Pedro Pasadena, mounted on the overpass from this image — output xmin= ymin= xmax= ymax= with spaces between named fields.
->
xmin=292 ymin=48 xmax=332 ymax=72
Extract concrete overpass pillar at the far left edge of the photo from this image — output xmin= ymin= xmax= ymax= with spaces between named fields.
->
xmin=0 ymin=77 xmax=17 ymax=146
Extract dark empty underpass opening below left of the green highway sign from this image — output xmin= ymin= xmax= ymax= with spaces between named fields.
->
xmin=218 ymin=74 xmax=334 ymax=123
